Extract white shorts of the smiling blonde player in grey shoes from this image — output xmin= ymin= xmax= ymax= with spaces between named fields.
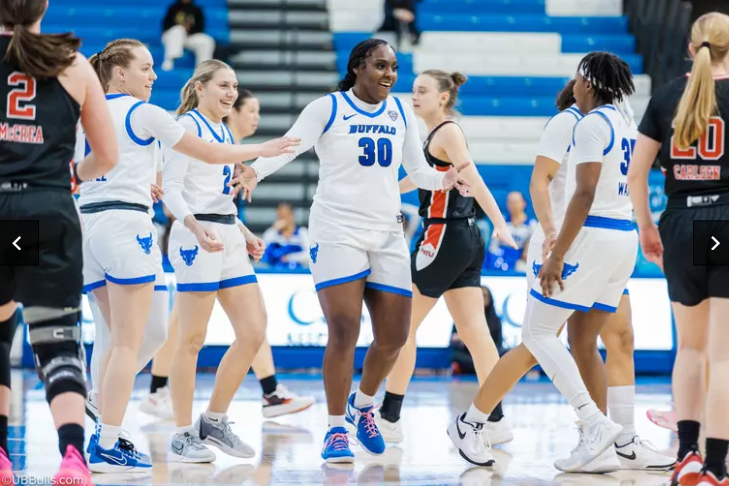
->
xmin=168 ymin=221 xmax=258 ymax=292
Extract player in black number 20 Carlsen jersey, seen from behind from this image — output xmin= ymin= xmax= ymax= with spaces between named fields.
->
xmin=628 ymin=13 xmax=729 ymax=486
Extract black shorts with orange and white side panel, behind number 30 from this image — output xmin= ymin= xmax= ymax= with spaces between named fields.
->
xmin=410 ymin=219 xmax=486 ymax=299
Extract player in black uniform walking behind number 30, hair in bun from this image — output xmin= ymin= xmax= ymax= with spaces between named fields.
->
xmin=379 ymin=70 xmax=516 ymax=443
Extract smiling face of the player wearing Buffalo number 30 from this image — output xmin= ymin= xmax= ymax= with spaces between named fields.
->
xmin=354 ymin=44 xmax=398 ymax=104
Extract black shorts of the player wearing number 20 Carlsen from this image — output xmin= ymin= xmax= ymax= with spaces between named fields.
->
xmin=658 ymin=205 xmax=729 ymax=306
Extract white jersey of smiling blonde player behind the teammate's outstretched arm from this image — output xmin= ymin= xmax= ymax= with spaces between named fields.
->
xmin=165 ymin=109 xmax=237 ymax=215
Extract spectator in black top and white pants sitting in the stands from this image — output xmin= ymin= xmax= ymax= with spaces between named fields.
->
xmin=162 ymin=0 xmax=215 ymax=71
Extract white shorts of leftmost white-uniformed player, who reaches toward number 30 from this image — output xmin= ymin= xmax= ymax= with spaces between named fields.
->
xmin=81 ymin=209 xmax=165 ymax=292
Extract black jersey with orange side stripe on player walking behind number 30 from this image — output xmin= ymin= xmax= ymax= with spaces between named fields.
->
xmin=418 ymin=120 xmax=476 ymax=219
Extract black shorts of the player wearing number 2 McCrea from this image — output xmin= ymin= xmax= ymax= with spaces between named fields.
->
xmin=0 ymin=190 xmax=83 ymax=308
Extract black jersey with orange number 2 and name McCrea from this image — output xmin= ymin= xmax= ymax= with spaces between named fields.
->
xmin=0 ymin=35 xmax=81 ymax=191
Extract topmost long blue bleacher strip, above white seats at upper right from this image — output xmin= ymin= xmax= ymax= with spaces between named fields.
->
xmin=416 ymin=13 xmax=628 ymax=35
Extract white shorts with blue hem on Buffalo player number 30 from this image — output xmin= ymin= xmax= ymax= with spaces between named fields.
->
xmin=309 ymin=214 xmax=413 ymax=297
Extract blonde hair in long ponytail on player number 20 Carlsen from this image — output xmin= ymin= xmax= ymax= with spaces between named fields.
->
xmin=674 ymin=12 xmax=729 ymax=149
